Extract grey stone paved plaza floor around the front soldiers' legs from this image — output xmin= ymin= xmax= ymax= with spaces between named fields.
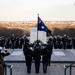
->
xmin=4 ymin=49 xmax=75 ymax=75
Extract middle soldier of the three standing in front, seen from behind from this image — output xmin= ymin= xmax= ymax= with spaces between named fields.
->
xmin=34 ymin=42 xmax=41 ymax=73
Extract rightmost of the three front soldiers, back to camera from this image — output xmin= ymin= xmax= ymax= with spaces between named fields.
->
xmin=41 ymin=45 xmax=49 ymax=73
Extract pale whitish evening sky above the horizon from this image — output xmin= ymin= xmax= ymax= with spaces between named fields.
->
xmin=0 ymin=0 xmax=75 ymax=21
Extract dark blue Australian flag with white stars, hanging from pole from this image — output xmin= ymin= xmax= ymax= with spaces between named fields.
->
xmin=38 ymin=17 xmax=51 ymax=34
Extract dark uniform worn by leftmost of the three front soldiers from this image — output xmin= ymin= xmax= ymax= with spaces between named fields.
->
xmin=25 ymin=47 xmax=33 ymax=73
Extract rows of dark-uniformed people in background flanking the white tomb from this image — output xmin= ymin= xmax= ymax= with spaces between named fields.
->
xmin=0 ymin=34 xmax=75 ymax=50
